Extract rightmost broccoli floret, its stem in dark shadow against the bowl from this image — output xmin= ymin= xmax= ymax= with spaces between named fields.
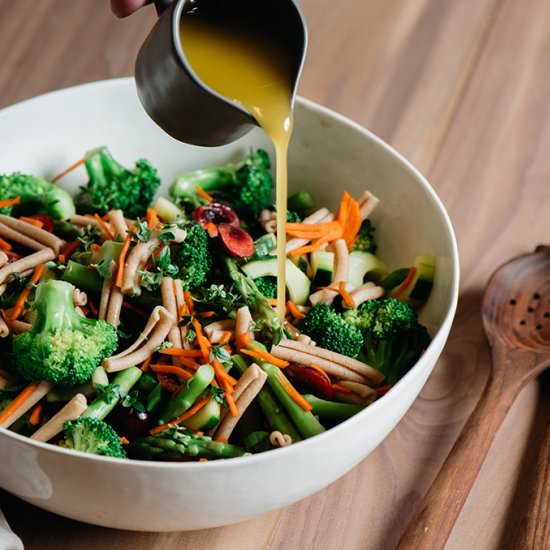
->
xmin=344 ymin=298 xmax=430 ymax=384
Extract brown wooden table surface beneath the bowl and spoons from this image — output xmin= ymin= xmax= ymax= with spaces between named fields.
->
xmin=0 ymin=0 xmax=550 ymax=550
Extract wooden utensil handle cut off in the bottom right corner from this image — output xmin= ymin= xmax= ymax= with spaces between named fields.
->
xmin=510 ymin=410 xmax=550 ymax=548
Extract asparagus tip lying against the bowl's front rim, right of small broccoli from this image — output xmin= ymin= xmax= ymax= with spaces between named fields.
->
xmin=128 ymin=427 xmax=246 ymax=460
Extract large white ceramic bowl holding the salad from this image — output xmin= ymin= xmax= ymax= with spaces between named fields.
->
xmin=0 ymin=79 xmax=458 ymax=531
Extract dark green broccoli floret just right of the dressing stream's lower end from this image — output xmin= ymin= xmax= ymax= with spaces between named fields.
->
xmin=298 ymin=303 xmax=363 ymax=357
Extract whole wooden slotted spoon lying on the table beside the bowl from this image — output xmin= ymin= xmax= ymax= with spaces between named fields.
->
xmin=397 ymin=246 xmax=550 ymax=550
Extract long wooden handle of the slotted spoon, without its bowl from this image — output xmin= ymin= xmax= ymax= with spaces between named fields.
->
xmin=397 ymin=354 xmax=519 ymax=550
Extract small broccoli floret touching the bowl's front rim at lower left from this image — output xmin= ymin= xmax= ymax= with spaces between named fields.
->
xmin=62 ymin=416 xmax=126 ymax=458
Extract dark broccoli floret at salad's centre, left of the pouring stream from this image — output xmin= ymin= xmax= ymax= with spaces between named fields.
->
xmin=172 ymin=222 xmax=212 ymax=290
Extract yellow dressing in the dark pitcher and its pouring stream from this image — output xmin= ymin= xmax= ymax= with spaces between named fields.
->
xmin=180 ymin=10 xmax=292 ymax=320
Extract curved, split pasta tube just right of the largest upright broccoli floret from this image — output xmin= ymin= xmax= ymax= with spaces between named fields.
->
xmin=103 ymin=306 xmax=176 ymax=372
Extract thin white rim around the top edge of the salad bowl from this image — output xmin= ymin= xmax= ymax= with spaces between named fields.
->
xmin=0 ymin=77 xmax=460 ymax=471
